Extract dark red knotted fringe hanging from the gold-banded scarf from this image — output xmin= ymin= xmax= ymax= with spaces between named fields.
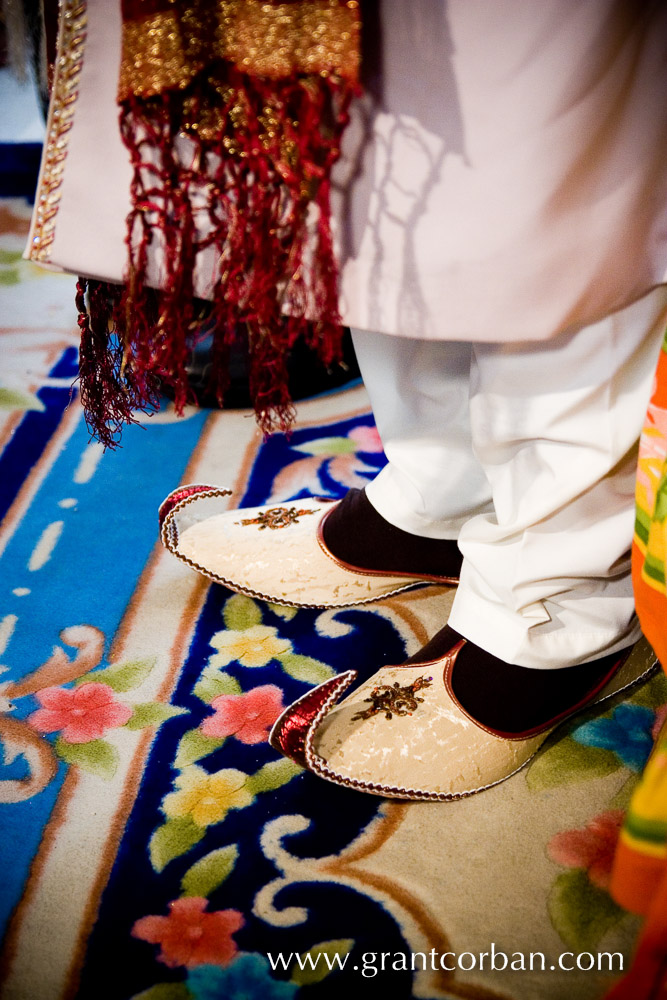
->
xmin=77 ymin=65 xmax=354 ymax=447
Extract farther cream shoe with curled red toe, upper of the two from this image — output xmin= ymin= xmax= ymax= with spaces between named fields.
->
xmin=159 ymin=485 xmax=458 ymax=608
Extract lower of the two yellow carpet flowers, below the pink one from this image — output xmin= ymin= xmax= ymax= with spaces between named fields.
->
xmin=162 ymin=764 xmax=254 ymax=826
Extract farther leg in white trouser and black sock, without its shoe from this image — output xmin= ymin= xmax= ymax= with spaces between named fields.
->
xmin=324 ymin=330 xmax=492 ymax=578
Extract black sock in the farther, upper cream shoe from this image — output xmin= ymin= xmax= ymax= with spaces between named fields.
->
xmin=323 ymin=490 xmax=463 ymax=579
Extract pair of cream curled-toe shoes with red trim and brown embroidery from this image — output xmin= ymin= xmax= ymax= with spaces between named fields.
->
xmin=159 ymin=485 xmax=656 ymax=801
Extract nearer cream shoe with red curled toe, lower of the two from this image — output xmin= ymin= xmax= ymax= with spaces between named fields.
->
xmin=269 ymin=630 xmax=657 ymax=801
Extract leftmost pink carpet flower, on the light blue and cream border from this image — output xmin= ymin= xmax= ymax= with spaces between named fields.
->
xmin=27 ymin=683 xmax=132 ymax=743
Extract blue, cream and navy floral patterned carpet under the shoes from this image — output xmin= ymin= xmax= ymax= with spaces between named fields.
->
xmin=0 ymin=200 xmax=667 ymax=1000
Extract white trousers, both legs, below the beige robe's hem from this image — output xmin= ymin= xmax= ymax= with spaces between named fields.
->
xmin=353 ymin=285 xmax=667 ymax=667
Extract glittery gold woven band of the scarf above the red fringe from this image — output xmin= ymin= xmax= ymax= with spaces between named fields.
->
xmin=118 ymin=0 xmax=360 ymax=101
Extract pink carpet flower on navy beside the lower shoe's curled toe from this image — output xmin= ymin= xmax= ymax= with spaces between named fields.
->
xmin=201 ymin=684 xmax=285 ymax=743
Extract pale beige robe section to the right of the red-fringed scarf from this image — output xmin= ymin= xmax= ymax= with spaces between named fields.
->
xmin=335 ymin=0 xmax=667 ymax=341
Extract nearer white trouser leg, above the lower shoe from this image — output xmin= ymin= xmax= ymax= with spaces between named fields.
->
xmin=450 ymin=286 xmax=667 ymax=668
